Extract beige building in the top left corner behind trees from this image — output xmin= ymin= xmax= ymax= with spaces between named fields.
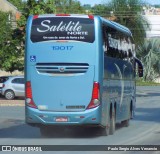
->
xmin=0 ymin=0 xmax=21 ymax=29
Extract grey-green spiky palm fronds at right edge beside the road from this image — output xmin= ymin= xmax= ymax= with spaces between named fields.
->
xmin=138 ymin=39 xmax=160 ymax=81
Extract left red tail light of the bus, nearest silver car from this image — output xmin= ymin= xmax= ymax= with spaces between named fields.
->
xmin=25 ymin=81 xmax=37 ymax=108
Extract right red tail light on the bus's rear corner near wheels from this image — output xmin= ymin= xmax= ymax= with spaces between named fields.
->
xmin=87 ymin=82 xmax=100 ymax=109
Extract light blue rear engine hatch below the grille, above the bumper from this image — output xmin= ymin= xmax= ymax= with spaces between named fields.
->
xmin=31 ymin=66 xmax=94 ymax=111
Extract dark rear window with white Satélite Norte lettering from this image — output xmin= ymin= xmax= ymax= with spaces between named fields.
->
xmin=31 ymin=17 xmax=95 ymax=43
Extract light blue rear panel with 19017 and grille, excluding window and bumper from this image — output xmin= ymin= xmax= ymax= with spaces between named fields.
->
xmin=27 ymin=43 xmax=96 ymax=111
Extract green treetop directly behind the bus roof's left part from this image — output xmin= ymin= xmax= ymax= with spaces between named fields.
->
xmin=18 ymin=0 xmax=83 ymax=38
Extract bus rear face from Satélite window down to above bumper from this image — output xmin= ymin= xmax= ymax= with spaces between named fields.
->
xmin=28 ymin=16 xmax=96 ymax=111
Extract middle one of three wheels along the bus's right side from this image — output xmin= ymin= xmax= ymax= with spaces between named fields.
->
xmin=109 ymin=111 xmax=116 ymax=135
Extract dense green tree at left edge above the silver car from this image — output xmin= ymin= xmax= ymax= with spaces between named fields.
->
xmin=0 ymin=12 xmax=23 ymax=72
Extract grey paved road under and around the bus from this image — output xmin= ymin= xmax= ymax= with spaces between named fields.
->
xmin=0 ymin=87 xmax=160 ymax=154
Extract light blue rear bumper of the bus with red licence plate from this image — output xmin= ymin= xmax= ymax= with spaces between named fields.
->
xmin=26 ymin=106 xmax=101 ymax=125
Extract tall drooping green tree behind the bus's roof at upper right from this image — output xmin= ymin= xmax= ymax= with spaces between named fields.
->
xmin=103 ymin=0 xmax=149 ymax=47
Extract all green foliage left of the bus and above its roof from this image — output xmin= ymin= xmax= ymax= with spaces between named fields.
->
xmin=0 ymin=0 xmax=83 ymax=72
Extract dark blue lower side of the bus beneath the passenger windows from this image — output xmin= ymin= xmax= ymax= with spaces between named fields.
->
xmin=102 ymin=57 xmax=135 ymax=124
